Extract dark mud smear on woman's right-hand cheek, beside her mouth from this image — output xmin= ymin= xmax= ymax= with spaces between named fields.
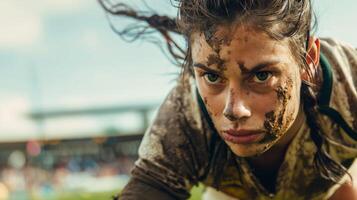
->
xmin=261 ymin=80 xmax=293 ymax=143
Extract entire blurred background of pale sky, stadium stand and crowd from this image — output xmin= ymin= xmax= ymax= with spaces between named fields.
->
xmin=0 ymin=0 xmax=357 ymax=200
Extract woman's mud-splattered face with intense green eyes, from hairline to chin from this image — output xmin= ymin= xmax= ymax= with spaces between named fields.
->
xmin=191 ymin=26 xmax=301 ymax=156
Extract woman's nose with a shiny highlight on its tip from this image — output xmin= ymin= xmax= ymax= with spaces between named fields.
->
xmin=223 ymin=89 xmax=251 ymax=121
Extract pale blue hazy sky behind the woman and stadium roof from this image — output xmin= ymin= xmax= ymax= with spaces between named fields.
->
xmin=0 ymin=0 xmax=357 ymax=140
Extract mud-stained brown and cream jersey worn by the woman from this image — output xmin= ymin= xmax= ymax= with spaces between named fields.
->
xmin=121 ymin=39 xmax=357 ymax=200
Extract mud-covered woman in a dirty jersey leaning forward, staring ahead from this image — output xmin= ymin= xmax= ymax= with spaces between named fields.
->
xmin=100 ymin=0 xmax=357 ymax=199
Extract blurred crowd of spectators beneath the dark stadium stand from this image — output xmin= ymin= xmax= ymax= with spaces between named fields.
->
xmin=0 ymin=141 xmax=136 ymax=200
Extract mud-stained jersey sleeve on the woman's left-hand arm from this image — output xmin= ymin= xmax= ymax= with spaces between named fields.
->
xmin=121 ymin=79 xmax=208 ymax=200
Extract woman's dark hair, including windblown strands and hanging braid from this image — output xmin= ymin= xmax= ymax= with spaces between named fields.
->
xmin=99 ymin=0 xmax=348 ymax=186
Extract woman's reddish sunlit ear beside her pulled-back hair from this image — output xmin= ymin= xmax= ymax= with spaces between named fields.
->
xmin=301 ymin=36 xmax=320 ymax=82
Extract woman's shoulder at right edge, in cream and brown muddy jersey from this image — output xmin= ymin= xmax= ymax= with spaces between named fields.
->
xmin=320 ymin=38 xmax=357 ymax=148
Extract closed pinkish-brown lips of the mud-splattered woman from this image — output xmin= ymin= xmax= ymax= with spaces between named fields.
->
xmin=222 ymin=129 xmax=265 ymax=144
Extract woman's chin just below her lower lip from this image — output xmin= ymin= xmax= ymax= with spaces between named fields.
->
xmin=226 ymin=142 xmax=269 ymax=157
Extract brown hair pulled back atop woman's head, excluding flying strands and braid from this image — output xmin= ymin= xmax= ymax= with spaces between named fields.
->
xmin=178 ymin=0 xmax=313 ymax=76
